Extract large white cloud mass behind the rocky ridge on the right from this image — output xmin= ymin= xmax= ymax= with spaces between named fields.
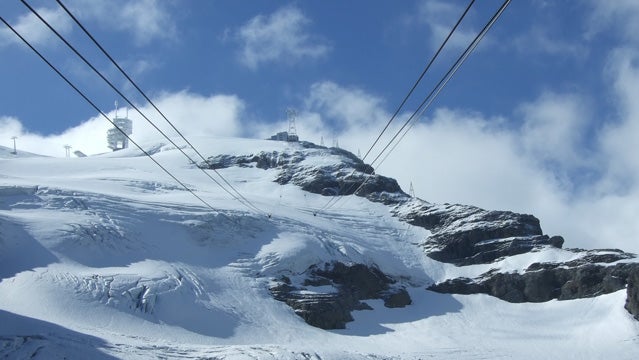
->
xmin=278 ymin=78 xmax=639 ymax=252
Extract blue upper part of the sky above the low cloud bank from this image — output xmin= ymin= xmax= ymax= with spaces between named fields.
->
xmin=0 ymin=0 xmax=608 ymax=134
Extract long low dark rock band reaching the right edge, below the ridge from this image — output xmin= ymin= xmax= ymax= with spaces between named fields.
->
xmin=429 ymin=252 xmax=639 ymax=303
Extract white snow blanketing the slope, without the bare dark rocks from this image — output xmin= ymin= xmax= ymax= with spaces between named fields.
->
xmin=0 ymin=138 xmax=639 ymax=359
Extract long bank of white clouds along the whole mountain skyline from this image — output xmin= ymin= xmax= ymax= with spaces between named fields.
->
xmin=0 ymin=67 xmax=639 ymax=252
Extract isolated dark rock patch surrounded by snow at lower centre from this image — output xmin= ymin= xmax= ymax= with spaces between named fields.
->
xmin=270 ymin=262 xmax=411 ymax=329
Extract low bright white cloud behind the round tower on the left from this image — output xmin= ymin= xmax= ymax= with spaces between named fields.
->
xmin=0 ymin=91 xmax=244 ymax=157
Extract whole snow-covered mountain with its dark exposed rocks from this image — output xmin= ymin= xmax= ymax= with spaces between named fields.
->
xmin=0 ymin=137 xmax=639 ymax=359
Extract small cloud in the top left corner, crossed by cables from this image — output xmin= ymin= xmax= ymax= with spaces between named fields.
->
xmin=0 ymin=8 xmax=72 ymax=47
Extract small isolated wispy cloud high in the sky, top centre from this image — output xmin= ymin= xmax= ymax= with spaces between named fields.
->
xmin=236 ymin=6 xmax=330 ymax=69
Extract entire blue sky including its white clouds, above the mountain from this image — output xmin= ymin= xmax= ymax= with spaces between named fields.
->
xmin=0 ymin=0 xmax=639 ymax=251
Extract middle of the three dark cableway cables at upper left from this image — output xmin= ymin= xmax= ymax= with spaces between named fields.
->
xmin=20 ymin=0 xmax=266 ymax=214
